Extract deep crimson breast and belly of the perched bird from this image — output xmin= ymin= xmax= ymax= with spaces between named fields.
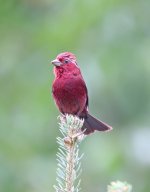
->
xmin=53 ymin=76 xmax=87 ymax=114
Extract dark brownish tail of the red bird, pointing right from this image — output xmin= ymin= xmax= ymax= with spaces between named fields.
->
xmin=82 ymin=114 xmax=112 ymax=135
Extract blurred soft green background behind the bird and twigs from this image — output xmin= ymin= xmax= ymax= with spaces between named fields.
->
xmin=0 ymin=0 xmax=150 ymax=192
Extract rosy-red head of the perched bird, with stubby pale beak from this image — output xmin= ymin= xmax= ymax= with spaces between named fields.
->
xmin=52 ymin=52 xmax=77 ymax=67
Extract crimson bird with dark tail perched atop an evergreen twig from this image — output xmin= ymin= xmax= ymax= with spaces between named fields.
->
xmin=52 ymin=52 xmax=112 ymax=135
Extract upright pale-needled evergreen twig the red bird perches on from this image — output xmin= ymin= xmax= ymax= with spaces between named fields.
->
xmin=54 ymin=115 xmax=84 ymax=192
